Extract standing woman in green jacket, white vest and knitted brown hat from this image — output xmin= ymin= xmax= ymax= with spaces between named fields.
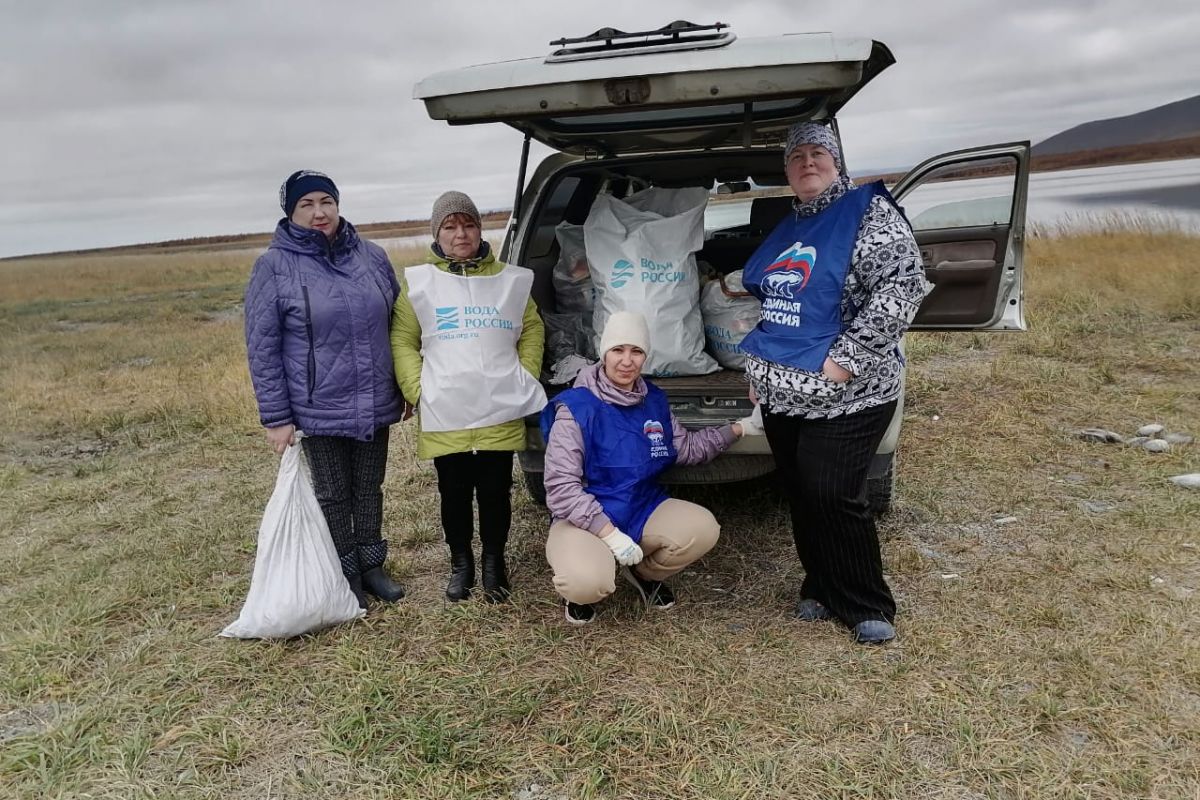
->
xmin=391 ymin=192 xmax=546 ymax=602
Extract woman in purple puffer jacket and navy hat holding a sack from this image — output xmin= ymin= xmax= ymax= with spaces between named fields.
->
xmin=246 ymin=170 xmax=404 ymax=608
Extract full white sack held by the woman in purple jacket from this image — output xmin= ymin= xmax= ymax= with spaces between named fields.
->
xmin=221 ymin=432 xmax=364 ymax=639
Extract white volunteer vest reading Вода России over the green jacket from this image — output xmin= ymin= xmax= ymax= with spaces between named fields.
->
xmin=404 ymin=264 xmax=546 ymax=431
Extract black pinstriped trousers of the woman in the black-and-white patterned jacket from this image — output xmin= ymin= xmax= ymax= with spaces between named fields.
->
xmin=763 ymin=401 xmax=896 ymax=626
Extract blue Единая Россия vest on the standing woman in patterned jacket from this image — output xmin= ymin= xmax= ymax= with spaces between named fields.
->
xmin=740 ymin=181 xmax=894 ymax=372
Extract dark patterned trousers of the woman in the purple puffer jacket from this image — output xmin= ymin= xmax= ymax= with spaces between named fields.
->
xmin=300 ymin=427 xmax=389 ymax=572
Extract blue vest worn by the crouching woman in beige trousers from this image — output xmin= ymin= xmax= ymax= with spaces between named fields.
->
xmin=541 ymin=381 xmax=676 ymax=542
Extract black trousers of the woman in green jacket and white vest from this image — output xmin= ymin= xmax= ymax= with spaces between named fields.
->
xmin=433 ymin=450 xmax=512 ymax=554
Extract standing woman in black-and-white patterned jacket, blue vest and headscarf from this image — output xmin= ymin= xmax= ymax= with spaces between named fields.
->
xmin=742 ymin=122 xmax=926 ymax=644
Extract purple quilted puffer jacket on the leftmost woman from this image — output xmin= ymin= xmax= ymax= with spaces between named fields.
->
xmin=246 ymin=219 xmax=402 ymax=441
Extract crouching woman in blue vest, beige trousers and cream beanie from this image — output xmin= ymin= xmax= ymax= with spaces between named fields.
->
xmin=541 ymin=312 xmax=762 ymax=625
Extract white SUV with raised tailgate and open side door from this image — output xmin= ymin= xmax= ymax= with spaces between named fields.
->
xmin=414 ymin=22 xmax=1030 ymax=513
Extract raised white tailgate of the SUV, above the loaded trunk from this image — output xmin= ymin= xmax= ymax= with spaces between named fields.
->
xmin=413 ymin=28 xmax=895 ymax=156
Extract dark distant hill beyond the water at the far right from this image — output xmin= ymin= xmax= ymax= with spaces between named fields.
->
xmin=1033 ymin=95 xmax=1200 ymax=156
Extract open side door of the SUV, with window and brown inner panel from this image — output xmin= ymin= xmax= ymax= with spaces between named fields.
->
xmin=892 ymin=142 xmax=1030 ymax=331
